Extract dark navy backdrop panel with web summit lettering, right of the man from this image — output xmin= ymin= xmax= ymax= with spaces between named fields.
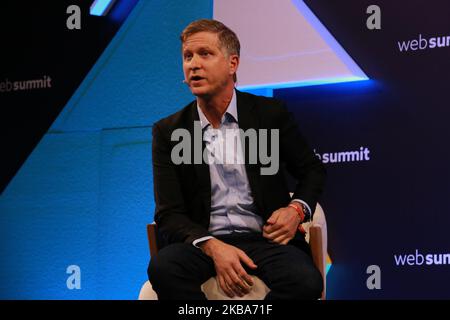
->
xmin=275 ymin=0 xmax=450 ymax=299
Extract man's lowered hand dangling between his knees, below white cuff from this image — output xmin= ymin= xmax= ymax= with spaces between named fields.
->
xmin=200 ymin=238 xmax=257 ymax=298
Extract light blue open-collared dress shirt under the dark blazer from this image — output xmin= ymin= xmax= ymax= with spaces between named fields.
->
xmin=193 ymin=91 xmax=264 ymax=245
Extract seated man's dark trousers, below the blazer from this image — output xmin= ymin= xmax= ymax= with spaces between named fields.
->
xmin=148 ymin=233 xmax=323 ymax=300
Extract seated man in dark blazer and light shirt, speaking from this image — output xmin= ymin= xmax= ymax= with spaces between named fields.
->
xmin=148 ymin=20 xmax=325 ymax=299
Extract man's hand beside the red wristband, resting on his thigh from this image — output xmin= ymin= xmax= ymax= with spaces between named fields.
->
xmin=263 ymin=207 xmax=301 ymax=244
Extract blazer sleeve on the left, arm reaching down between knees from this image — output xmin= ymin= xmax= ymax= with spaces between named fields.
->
xmin=152 ymin=123 xmax=210 ymax=243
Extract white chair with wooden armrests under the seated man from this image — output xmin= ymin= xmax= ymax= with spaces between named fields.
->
xmin=139 ymin=204 xmax=327 ymax=300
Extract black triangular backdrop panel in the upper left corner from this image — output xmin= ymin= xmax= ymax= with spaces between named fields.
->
xmin=0 ymin=0 xmax=138 ymax=192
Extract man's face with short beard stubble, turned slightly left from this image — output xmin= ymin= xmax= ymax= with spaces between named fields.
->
xmin=182 ymin=32 xmax=239 ymax=97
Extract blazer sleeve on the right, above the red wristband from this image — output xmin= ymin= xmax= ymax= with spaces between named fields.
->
xmin=277 ymin=104 xmax=326 ymax=215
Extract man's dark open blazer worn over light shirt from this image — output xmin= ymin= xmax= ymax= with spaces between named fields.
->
xmin=152 ymin=91 xmax=325 ymax=243
